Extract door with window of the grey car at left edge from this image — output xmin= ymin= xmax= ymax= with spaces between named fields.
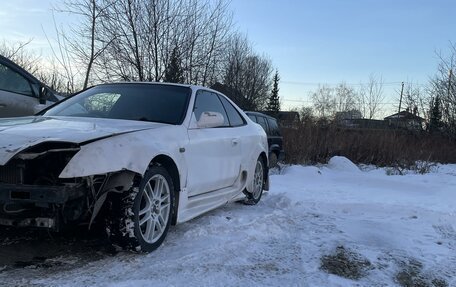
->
xmin=0 ymin=62 xmax=39 ymax=117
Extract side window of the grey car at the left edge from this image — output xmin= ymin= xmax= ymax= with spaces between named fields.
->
xmin=0 ymin=64 xmax=33 ymax=96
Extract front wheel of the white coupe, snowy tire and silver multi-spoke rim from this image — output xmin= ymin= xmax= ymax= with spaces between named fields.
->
xmin=108 ymin=165 xmax=174 ymax=252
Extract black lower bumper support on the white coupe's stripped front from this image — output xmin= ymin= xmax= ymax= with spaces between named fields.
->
xmin=0 ymin=183 xmax=86 ymax=230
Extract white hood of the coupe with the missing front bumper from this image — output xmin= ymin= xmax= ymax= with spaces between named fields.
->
xmin=0 ymin=117 xmax=166 ymax=165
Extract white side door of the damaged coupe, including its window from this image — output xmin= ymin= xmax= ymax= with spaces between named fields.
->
xmin=185 ymin=90 xmax=241 ymax=196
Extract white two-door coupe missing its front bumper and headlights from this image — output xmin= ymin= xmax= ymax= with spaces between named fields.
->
xmin=0 ymin=83 xmax=269 ymax=252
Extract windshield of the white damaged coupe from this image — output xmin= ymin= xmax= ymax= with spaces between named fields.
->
xmin=44 ymin=83 xmax=191 ymax=124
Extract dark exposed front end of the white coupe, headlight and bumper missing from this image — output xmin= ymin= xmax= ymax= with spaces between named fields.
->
xmin=0 ymin=142 xmax=135 ymax=231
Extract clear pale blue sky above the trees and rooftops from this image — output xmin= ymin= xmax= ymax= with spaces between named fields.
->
xmin=0 ymin=0 xmax=456 ymax=112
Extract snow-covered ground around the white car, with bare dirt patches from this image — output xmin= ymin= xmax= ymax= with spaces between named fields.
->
xmin=0 ymin=157 xmax=456 ymax=287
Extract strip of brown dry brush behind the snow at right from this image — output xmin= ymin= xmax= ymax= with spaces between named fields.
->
xmin=282 ymin=121 xmax=456 ymax=166
